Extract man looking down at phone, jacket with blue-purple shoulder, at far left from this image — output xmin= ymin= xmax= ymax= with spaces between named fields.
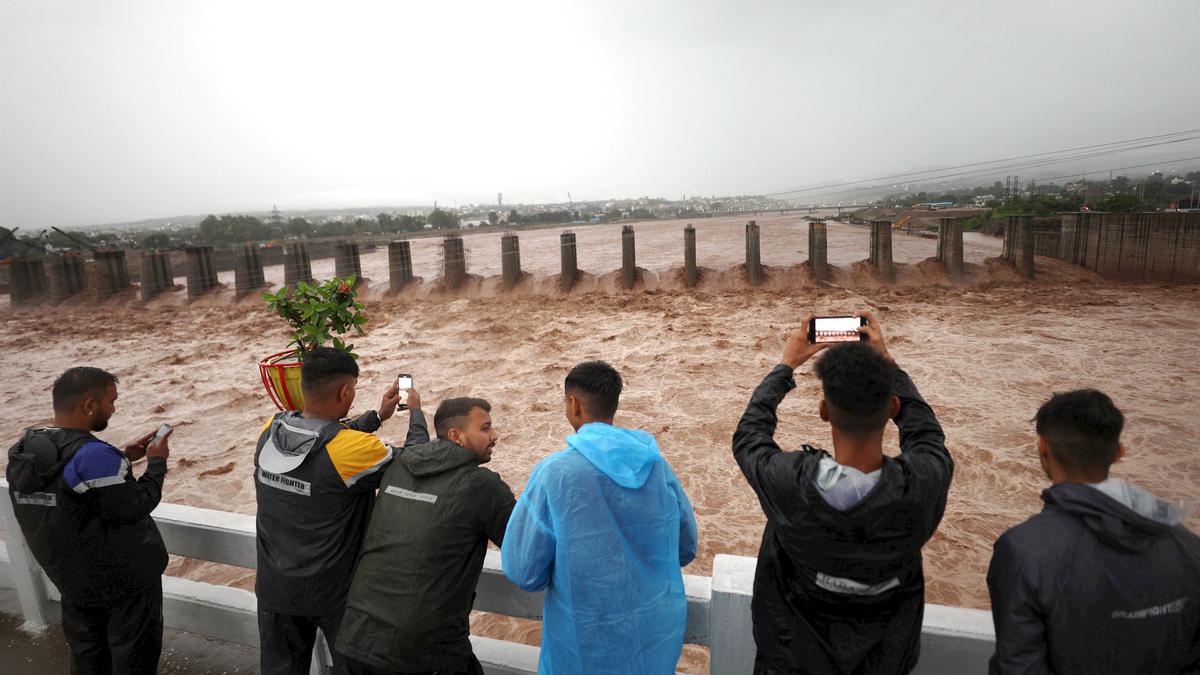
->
xmin=7 ymin=366 xmax=170 ymax=674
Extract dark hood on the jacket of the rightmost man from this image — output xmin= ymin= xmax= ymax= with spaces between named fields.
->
xmin=1042 ymin=483 xmax=1180 ymax=552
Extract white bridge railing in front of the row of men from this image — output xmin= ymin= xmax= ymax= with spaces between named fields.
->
xmin=0 ymin=479 xmax=995 ymax=675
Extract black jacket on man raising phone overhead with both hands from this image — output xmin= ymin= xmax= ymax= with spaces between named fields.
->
xmin=733 ymin=365 xmax=954 ymax=674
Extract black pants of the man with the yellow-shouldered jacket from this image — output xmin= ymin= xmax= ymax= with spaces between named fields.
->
xmin=258 ymin=609 xmax=346 ymax=675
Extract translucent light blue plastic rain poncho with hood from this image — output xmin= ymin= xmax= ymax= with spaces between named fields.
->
xmin=500 ymin=423 xmax=696 ymax=675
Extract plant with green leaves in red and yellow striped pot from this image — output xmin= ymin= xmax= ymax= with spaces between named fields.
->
xmin=258 ymin=274 xmax=367 ymax=410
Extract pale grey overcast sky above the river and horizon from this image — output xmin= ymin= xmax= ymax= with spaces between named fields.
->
xmin=0 ymin=0 xmax=1200 ymax=228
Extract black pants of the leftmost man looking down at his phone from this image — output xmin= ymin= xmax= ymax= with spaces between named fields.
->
xmin=62 ymin=580 xmax=162 ymax=675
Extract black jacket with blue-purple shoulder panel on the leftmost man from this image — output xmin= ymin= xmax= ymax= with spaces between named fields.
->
xmin=6 ymin=428 xmax=167 ymax=605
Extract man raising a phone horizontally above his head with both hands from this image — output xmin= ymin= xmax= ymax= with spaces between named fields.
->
xmin=733 ymin=313 xmax=954 ymax=674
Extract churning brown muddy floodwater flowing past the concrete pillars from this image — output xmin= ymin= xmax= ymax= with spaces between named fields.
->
xmin=0 ymin=216 xmax=1200 ymax=668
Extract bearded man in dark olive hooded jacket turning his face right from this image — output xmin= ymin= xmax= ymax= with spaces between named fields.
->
xmin=337 ymin=398 xmax=516 ymax=675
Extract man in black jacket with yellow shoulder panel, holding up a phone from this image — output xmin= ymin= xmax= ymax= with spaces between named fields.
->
xmin=254 ymin=347 xmax=428 ymax=675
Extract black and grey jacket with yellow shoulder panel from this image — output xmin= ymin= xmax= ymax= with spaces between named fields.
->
xmin=254 ymin=411 xmax=428 ymax=616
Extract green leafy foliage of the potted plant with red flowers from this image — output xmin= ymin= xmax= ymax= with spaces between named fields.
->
xmin=263 ymin=274 xmax=367 ymax=358
